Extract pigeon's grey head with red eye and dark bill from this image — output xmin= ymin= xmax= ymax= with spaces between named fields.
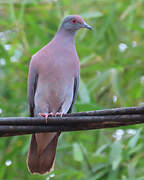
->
xmin=60 ymin=15 xmax=92 ymax=32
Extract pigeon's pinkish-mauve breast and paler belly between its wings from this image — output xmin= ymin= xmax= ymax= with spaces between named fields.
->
xmin=35 ymin=44 xmax=79 ymax=110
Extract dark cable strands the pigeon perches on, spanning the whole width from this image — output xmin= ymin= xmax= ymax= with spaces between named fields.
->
xmin=0 ymin=107 xmax=144 ymax=137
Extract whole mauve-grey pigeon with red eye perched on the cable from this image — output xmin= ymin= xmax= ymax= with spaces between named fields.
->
xmin=27 ymin=15 xmax=92 ymax=174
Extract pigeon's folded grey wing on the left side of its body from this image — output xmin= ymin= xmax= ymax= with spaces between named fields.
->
xmin=28 ymin=60 xmax=38 ymax=117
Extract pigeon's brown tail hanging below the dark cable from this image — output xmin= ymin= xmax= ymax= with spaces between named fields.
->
xmin=27 ymin=133 xmax=59 ymax=174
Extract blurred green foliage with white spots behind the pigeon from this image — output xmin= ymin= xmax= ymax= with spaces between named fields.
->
xmin=0 ymin=0 xmax=144 ymax=180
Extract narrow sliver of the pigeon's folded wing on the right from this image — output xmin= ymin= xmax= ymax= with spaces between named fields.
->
xmin=68 ymin=74 xmax=80 ymax=113
